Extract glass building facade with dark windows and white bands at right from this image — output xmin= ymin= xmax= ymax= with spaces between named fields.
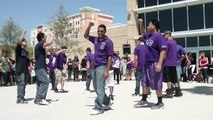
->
xmin=131 ymin=0 xmax=213 ymax=72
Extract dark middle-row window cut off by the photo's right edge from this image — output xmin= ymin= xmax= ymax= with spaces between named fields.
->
xmin=205 ymin=3 xmax=213 ymax=28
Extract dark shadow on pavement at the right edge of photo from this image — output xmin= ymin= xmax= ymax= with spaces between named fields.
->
xmin=182 ymin=86 xmax=213 ymax=95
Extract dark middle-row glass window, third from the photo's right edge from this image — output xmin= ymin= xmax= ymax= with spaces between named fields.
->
xmin=173 ymin=8 xmax=187 ymax=31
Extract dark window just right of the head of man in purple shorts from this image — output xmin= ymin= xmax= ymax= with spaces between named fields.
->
xmin=159 ymin=10 xmax=172 ymax=32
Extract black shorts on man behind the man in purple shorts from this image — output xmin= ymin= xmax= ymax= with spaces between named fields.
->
xmin=163 ymin=66 xmax=177 ymax=83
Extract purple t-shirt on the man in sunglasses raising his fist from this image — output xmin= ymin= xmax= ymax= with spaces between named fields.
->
xmin=89 ymin=36 xmax=114 ymax=68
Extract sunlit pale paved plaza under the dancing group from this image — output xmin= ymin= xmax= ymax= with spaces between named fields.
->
xmin=0 ymin=81 xmax=213 ymax=120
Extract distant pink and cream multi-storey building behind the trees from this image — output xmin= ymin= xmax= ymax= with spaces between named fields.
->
xmin=30 ymin=7 xmax=113 ymax=46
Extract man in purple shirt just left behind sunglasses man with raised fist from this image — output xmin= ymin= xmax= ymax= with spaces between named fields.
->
xmin=86 ymin=47 xmax=96 ymax=91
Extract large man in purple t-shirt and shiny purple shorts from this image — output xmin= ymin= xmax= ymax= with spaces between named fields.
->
xmin=135 ymin=20 xmax=167 ymax=109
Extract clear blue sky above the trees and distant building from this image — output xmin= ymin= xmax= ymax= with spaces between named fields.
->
xmin=0 ymin=0 xmax=127 ymax=39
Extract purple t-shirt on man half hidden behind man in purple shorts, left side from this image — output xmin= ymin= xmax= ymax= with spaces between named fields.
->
xmin=134 ymin=43 xmax=146 ymax=68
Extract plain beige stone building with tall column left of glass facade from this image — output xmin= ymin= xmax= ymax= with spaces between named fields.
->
xmin=75 ymin=0 xmax=139 ymax=59
